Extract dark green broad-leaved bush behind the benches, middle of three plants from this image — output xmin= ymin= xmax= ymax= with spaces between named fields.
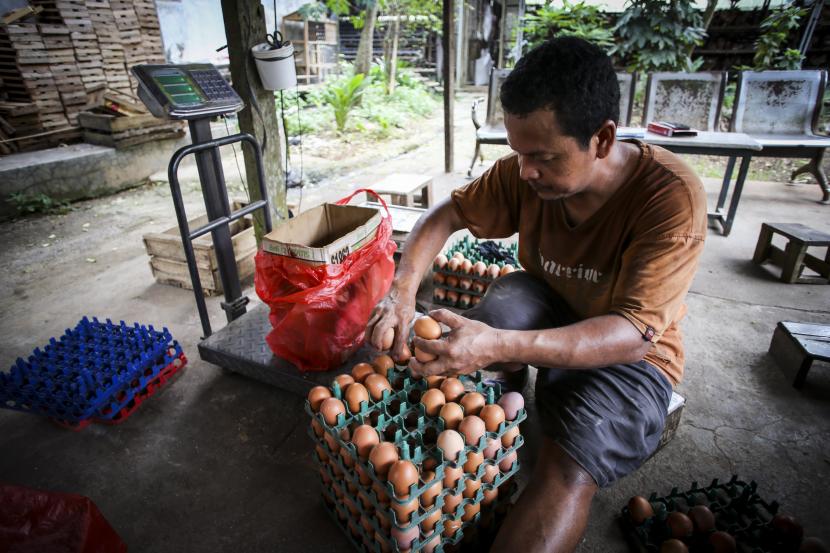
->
xmin=611 ymin=0 xmax=706 ymax=72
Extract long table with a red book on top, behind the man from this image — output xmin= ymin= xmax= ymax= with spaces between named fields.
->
xmin=620 ymin=128 xmax=762 ymax=236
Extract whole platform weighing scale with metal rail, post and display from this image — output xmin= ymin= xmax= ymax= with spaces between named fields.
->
xmin=132 ymin=64 xmax=366 ymax=396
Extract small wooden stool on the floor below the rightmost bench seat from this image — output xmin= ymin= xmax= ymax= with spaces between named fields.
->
xmin=752 ymin=223 xmax=830 ymax=284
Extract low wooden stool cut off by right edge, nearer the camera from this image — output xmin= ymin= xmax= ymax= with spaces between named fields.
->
xmin=769 ymin=321 xmax=830 ymax=389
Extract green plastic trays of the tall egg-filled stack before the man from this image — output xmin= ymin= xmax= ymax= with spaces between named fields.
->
xmin=305 ymin=367 xmax=527 ymax=553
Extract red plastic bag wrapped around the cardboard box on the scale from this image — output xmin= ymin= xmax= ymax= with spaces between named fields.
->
xmin=254 ymin=189 xmax=397 ymax=371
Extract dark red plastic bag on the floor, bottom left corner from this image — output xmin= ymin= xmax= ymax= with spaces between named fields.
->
xmin=0 ymin=484 xmax=127 ymax=553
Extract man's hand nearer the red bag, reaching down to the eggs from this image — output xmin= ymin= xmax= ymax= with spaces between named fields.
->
xmin=366 ymin=286 xmax=415 ymax=364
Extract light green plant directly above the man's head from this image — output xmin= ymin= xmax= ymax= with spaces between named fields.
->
xmin=522 ymin=0 xmax=614 ymax=51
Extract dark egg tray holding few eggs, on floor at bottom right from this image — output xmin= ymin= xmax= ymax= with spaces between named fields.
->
xmin=619 ymin=475 xmax=780 ymax=553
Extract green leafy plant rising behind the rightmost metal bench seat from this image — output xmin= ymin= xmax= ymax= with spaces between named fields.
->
xmin=752 ymin=5 xmax=807 ymax=71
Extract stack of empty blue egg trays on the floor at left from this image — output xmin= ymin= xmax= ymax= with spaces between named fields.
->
xmin=0 ymin=317 xmax=182 ymax=426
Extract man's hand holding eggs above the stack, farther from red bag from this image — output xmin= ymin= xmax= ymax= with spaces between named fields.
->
xmin=409 ymin=309 xmax=503 ymax=376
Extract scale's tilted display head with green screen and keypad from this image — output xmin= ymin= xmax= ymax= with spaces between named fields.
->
xmin=132 ymin=63 xmax=245 ymax=119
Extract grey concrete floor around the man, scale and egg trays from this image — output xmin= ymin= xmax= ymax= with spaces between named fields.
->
xmin=0 ymin=100 xmax=830 ymax=553
